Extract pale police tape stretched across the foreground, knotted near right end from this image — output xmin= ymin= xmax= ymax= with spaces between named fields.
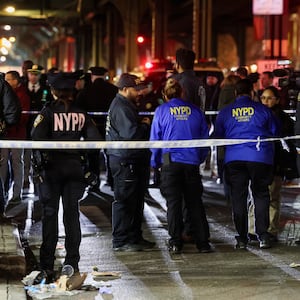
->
xmin=0 ymin=135 xmax=300 ymax=151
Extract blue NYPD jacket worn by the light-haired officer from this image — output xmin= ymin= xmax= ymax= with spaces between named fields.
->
xmin=150 ymin=98 xmax=208 ymax=168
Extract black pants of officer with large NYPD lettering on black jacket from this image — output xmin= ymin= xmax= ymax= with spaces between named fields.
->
xmin=39 ymin=159 xmax=86 ymax=270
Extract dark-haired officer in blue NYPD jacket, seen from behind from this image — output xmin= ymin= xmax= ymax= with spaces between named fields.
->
xmin=216 ymin=79 xmax=278 ymax=249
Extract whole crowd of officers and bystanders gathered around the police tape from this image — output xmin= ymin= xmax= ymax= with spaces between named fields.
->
xmin=0 ymin=48 xmax=299 ymax=281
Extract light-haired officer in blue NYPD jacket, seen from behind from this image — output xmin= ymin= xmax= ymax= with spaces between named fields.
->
xmin=150 ymin=78 xmax=211 ymax=254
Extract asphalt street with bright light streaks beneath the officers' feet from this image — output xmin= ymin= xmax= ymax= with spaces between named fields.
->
xmin=8 ymin=171 xmax=300 ymax=300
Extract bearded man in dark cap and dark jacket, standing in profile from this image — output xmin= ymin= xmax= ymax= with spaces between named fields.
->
xmin=106 ymin=73 xmax=154 ymax=252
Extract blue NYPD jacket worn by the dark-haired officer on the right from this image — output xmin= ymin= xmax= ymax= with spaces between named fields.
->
xmin=215 ymin=96 xmax=278 ymax=165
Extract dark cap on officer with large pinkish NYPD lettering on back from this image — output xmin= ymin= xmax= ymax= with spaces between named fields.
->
xmin=47 ymin=72 xmax=77 ymax=90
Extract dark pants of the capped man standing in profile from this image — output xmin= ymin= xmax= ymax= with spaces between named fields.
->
xmin=109 ymin=156 xmax=149 ymax=247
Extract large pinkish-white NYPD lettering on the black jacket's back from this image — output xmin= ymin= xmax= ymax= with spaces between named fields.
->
xmin=53 ymin=112 xmax=85 ymax=131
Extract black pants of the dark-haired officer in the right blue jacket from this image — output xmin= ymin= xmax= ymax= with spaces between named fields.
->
xmin=225 ymin=161 xmax=273 ymax=242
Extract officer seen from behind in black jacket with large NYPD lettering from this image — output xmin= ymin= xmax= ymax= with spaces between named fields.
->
xmin=31 ymin=73 xmax=100 ymax=281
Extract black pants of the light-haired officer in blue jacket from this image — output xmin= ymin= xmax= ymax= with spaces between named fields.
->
xmin=160 ymin=162 xmax=209 ymax=247
